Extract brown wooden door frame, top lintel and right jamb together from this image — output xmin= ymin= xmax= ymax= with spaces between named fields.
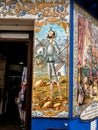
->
xmin=0 ymin=18 xmax=34 ymax=130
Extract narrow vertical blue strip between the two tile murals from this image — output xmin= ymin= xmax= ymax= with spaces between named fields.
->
xmin=69 ymin=0 xmax=74 ymax=118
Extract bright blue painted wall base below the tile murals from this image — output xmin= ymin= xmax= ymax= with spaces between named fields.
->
xmin=31 ymin=118 xmax=98 ymax=130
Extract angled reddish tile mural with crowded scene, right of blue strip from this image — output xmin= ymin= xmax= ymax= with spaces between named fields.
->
xmin=73 ymin=6 xmax=98 ymax=116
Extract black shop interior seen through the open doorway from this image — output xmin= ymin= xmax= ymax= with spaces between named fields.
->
xmin=0 ymin=40 xmax=28 ymax=130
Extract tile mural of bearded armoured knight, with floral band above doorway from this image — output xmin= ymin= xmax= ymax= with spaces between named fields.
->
xmin=0 ymin=0 xmax=70 ymax=118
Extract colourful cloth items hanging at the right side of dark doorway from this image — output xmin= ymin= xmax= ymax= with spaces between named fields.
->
xmin=17 ymin=67 xmax=27 ymax=128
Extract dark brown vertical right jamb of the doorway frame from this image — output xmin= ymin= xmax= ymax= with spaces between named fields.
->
xmin=26 ymin=32 xmax=33 ymax=130
